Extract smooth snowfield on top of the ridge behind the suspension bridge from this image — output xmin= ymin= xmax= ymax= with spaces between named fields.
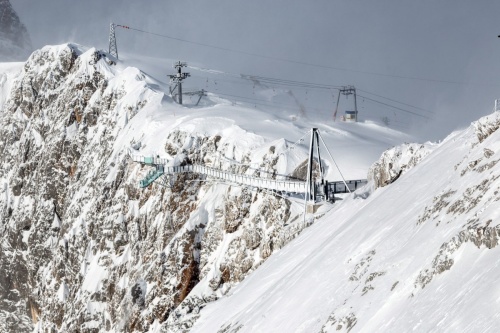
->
xmin=107 ymin=54 xmax=415 ymax=181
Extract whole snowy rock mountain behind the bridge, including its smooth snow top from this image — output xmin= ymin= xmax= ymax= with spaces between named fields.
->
xmin=0 ymin=44 xmax=426 ymax=332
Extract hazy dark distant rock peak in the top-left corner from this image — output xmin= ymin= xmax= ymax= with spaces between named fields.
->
xmin=0 ymin=0 xmax=31 ymax=61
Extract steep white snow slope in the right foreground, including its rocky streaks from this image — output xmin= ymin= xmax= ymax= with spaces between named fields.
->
xmin=192 ymin=112 xmax=500 ymax=332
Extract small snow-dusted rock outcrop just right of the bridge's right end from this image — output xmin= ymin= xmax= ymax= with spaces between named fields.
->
xmin=368 ymin=143 xmax=435 ymax=188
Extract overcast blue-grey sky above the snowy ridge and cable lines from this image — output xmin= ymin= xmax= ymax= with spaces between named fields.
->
xmin=11 ymin=0 xmax=500 ymax=139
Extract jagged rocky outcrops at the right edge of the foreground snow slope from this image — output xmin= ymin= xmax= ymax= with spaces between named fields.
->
xmin=415 ymin=112 xmax=500 ymax=289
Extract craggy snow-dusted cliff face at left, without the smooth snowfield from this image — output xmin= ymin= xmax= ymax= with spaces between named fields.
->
xmin=0 ymin=45 xmax=301 ymax=332
